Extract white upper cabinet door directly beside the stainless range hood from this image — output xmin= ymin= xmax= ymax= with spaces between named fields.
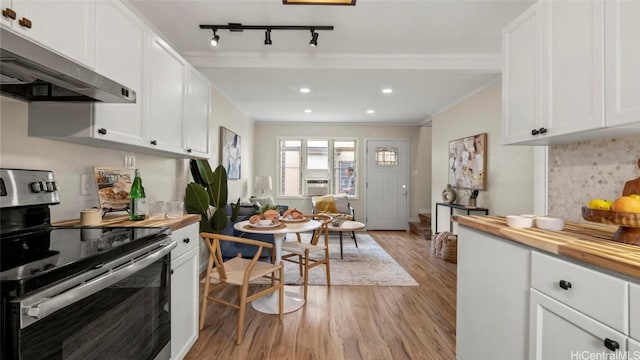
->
xmin=93 ymin=1 xmax=147 ymax=145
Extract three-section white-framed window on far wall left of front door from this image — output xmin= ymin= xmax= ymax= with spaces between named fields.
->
xmin=278 ymin=139 xmax=357 ymax=197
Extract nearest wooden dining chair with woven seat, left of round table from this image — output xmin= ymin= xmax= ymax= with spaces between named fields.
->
xmin=200 ymin=232 xmax=284 ymax=345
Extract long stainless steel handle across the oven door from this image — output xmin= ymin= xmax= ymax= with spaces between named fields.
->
xmin=21 ymin=241 xmax=176 ymax=328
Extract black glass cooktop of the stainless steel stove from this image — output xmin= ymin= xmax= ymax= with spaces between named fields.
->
xmin=0 ymin=227 xmax=170 ymax=297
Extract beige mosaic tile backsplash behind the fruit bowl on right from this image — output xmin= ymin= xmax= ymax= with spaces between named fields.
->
xmin=548 ymin=135 xmax=640 ymax=222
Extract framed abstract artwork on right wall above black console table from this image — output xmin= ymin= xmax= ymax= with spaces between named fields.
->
xmin=449 ymin=133 xmax=487 ymax=190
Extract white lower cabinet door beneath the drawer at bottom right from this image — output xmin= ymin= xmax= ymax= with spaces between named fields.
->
xmin=529 ymin=290 xmax=627 ymax=360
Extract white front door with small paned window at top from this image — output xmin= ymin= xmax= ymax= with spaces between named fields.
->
xmin=365 ymin=140 xmax=409 ymax=230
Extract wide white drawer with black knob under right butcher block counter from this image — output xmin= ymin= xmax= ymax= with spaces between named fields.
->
xmin=531 ymin=251 xmax=629 ymax=334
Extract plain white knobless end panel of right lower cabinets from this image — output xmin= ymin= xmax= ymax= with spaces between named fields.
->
xmin=456 ymin=226 xmax=532 ymax=360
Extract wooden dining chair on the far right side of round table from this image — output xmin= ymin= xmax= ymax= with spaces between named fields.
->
xmin=282 ymin=214 xmax=331 ymax=300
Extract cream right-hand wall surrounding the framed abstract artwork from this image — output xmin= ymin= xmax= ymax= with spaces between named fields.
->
xmin=431 ymin=81 xmax=533 ymax=231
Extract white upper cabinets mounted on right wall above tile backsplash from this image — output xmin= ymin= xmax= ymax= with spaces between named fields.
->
xmin=502 ymin=0 xmax=640 ymax=145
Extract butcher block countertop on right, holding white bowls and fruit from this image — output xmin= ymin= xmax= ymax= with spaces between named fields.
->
xmin=453 ymin=215 xmax=640 ymax=278
